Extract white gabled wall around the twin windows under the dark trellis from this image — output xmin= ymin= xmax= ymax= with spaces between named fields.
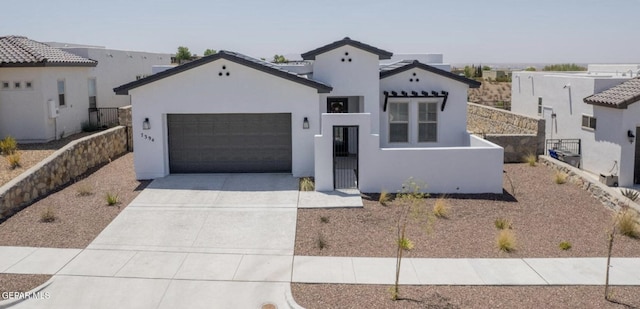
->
xmin=379 ymin=68 xmax=468 ymax=147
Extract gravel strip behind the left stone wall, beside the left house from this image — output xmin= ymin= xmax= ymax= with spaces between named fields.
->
xmin=0 ymin=132 xmax=95 ymax=186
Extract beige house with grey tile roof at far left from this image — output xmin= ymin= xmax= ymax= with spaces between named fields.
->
xmin=0 ymin=36 xmax=97 ymax=143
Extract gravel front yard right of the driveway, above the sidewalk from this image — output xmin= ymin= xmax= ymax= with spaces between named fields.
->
xmin=295 ymin=164 xmax=640 ymax=258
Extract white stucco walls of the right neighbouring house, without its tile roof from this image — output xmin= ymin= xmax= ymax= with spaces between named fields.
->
xmin=511 ymin=72 xmax=640 ymax=186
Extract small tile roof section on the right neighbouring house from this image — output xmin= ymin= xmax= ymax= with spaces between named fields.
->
xmin=584 ymin=77 xmax=640 ymax=109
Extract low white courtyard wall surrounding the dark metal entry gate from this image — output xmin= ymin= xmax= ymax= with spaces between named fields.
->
xmin=315 ymin=114 xmax=503 ymax=193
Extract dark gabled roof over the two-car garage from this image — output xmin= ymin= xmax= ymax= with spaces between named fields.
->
xmin=113 ymin=50 xmax=333 ymax=94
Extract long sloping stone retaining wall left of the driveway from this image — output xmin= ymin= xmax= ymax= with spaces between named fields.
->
xmin=0 ymin=126 xmax=127 ymax=222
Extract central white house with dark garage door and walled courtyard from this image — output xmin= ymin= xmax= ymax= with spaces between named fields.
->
xmin=114 ymin=38 xmax=503 ymax=193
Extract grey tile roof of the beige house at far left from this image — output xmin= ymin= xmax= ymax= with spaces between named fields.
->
xmin=0 ymin=36 xmax=98 ymax=67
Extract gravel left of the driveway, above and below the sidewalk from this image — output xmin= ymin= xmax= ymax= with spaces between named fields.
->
xmin=0 ymin=153 xmax=149 ymax=298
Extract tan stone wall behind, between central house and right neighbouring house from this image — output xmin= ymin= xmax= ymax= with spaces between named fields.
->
xmin=467 ymin=103 xmax=545 ymax=163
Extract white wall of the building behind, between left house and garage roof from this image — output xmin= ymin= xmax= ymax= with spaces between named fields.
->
xmin=61 ymin=47 xmax=171 ymax=107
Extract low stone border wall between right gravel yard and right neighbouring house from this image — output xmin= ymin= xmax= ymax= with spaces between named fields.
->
xmin=538 ymin=156 xmax=640 ymax=212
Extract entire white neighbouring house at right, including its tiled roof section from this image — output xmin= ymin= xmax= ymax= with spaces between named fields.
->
xmin=511 ymin=65 xmax=640 ymax=186
